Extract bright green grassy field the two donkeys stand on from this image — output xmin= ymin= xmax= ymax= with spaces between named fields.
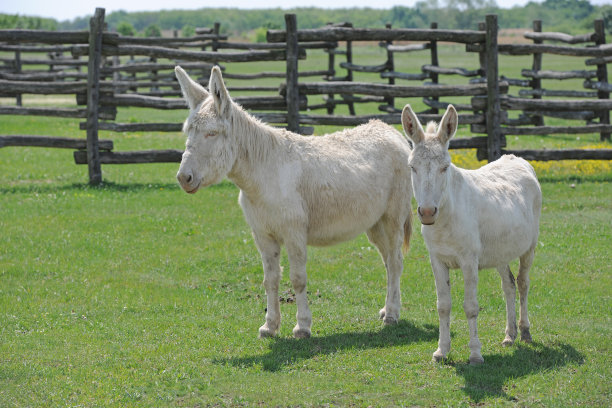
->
xmin=0 ymin=43 xmax=612 ymax=407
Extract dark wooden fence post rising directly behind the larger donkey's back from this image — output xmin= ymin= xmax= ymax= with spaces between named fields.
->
xmin=285 ymin=14 xmax=300 ymax=132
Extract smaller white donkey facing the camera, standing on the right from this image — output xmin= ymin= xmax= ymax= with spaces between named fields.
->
xmin=402 ymin=105 xmax=542 ymax=364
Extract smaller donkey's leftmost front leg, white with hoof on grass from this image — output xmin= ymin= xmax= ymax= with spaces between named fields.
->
xmin=430 ymin=256 xmax=452 ymax=361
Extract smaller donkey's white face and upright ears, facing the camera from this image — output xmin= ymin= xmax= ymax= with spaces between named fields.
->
xmin=402 ymin=105 xmax=458 ymax=225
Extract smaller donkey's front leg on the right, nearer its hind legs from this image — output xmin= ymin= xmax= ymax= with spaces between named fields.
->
xmin=461 ymin=260 xmax=484 ymax=365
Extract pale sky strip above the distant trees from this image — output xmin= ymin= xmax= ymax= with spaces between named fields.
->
xmin=0 ymin=0 xmax=612 ymax=21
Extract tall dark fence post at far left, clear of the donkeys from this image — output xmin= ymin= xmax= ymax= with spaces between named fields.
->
xmin=87 ymin=8 xmax=104 ymax=184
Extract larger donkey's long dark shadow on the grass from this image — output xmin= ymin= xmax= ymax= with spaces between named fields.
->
xmin=213 ymin=320 xmax=438 ymax=372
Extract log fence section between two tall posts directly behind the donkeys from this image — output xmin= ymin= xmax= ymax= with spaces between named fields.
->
xmin=267 ymin=15 xmax=508 ymax=156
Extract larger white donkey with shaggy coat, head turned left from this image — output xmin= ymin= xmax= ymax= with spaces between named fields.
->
xmin=176 ymin=67 xmax=412 ymax=338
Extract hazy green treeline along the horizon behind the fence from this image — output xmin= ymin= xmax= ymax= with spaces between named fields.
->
xmin=0 ymin=0 xmax=612 ymax=35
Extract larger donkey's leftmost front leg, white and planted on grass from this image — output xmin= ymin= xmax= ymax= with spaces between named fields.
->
xmin=253 ymin=233 xmax=281 ymax=338
